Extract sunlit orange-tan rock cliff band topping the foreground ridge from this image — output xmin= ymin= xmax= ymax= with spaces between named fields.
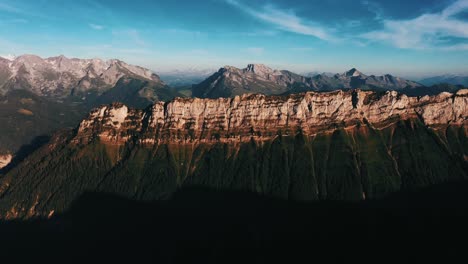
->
xmin=77 ymin=90 xmax=468 ymax=144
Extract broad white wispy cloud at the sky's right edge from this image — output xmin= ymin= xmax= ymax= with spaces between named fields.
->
xmin=361 ymin=0 xmax=468 ymax=50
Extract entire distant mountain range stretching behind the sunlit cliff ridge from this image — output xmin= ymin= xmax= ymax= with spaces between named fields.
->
xmin=0 ymin=55 xmax=463 ymax=171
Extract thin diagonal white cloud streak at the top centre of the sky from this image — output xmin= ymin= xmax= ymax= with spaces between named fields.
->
xmin=225 ymin=0 xmax=334 ymax=41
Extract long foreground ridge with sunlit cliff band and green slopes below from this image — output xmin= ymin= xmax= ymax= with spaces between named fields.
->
xmin=0 ymin=90 xmax=468 ymax=219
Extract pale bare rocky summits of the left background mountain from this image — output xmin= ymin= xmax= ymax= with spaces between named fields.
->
xmin=0 ymin=55 xmax=164 ymax=97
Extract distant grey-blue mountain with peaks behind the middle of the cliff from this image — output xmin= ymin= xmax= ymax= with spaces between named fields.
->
xmin=192 ymin=64 xmax=423 ymax=98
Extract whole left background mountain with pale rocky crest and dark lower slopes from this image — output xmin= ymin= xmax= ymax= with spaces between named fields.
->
xmin=0 ymin=55 xmax=182 ymax=158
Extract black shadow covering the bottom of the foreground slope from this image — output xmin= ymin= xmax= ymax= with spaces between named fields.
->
xmin=0 ymin=182 xmax=468 ymax=263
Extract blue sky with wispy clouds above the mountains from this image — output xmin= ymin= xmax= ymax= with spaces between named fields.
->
xmin=0 ymin=0 xmax=468 ymax=78
